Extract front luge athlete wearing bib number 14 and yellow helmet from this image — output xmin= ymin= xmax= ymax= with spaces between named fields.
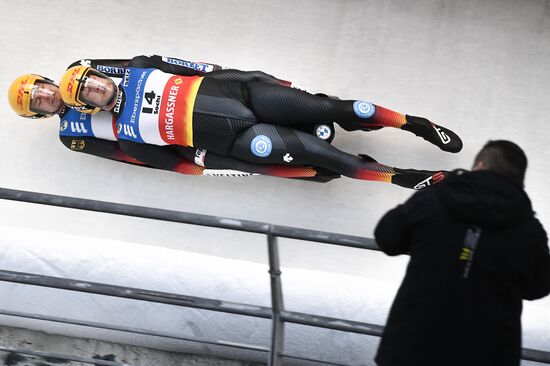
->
xmin=60 ymin=56 xmax=462 ymax=189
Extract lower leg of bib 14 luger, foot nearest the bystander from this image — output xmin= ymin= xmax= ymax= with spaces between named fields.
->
xmin=231 ymin=123 xmax=446 ymax=189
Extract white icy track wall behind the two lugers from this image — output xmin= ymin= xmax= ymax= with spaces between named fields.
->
xmin=0 ymin=0 xmax=550 ymax=364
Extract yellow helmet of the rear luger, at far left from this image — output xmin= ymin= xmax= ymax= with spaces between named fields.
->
xmin=8 ymin=74 xmax=57 ymax=118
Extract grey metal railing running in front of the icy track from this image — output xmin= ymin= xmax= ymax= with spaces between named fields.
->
xmin=0 ymin=188 xmax=550 ymax=366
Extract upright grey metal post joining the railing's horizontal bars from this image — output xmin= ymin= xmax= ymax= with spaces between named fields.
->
xmin=267 ymin=225 xmax=284 ymax=366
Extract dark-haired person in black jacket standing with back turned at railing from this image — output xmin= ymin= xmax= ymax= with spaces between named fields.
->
xmin=375 ymin=140 xmax=550 ymax=366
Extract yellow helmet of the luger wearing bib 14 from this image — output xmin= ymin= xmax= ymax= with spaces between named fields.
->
xmin=59 ymin=66 xmax=117 ymax=113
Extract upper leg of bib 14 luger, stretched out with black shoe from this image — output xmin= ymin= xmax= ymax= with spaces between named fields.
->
xmin=245 ymin=82 xmax=462 ymax=152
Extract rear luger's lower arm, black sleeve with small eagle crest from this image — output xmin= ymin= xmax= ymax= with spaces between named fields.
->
xmin=59 ymin=136 xmax=151 ymax=166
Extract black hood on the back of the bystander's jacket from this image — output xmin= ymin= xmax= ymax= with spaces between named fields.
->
xmin=437 ymin=170 xmax=533 ymax=227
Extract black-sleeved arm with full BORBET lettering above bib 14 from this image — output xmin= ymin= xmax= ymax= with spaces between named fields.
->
xmin=128 ymin=55 xmax=222 ymax=76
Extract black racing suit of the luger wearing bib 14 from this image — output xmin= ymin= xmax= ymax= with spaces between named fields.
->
xmin=115 ymin=56 xmax=452 ymax=189
